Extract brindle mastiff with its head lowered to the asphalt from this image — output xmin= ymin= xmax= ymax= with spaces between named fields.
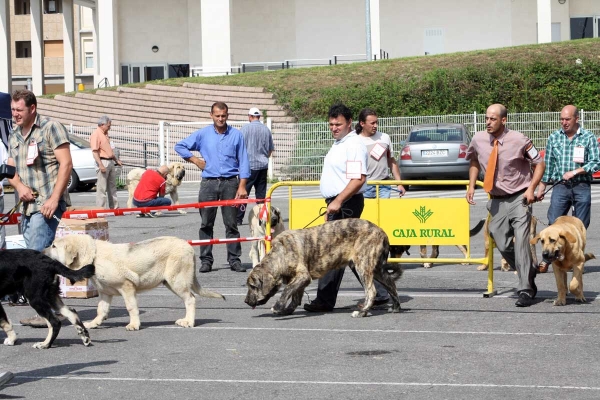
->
xmin=244 ymin=218 xmax=402 ymax=317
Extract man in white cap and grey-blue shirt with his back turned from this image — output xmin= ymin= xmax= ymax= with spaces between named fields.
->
xmin=237 ymin=107 xmax=274 ymax=225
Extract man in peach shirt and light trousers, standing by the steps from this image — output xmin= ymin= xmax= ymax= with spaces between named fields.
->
xmin=90 ymin=115 xmax=123 ymax=208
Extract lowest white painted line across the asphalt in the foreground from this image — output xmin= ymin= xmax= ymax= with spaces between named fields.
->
xmin=14 ymin=374 xmax=600 ymax=391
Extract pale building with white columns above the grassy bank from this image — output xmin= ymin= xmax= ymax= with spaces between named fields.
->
xmin=0 ymin=0 xmax=600 ymax=93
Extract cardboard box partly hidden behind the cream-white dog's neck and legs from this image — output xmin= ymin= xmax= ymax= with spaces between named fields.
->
xmin=56 ymin=218 xmax=108 ymax=299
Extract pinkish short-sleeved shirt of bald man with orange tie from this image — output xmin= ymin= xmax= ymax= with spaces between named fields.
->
xmin=466 ymin=129 xmax=542 ymax=196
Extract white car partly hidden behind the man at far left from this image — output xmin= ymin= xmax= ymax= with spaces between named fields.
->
xmin=67 ymin=135 xmax=97 ymax=192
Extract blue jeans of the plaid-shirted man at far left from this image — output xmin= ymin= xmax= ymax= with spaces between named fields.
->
xmin=21 ymin=200 xmax=67 ymax=251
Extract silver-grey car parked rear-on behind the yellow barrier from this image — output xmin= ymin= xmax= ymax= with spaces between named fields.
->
xmin=398 ymin=123 xmax=471 ymax=180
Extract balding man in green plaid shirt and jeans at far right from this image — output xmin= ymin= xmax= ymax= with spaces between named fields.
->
xmin=538 ymin=105 xmax=600 ymax=272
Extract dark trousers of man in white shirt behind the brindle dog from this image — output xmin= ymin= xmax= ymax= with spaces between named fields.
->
xmin=315 ymin=194 xmax=389 ymax=308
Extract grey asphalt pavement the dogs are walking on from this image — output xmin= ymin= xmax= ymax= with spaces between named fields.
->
xmin=0 ymin=183 xmax=600 ymax=400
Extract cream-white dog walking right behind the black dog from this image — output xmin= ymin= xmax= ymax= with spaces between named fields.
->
xmin=44 ymin=235 xmax=225 ymax=331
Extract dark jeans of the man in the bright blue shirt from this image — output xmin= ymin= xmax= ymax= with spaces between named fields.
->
xmin=198 ymin=177 xmax=242 ymax=266
